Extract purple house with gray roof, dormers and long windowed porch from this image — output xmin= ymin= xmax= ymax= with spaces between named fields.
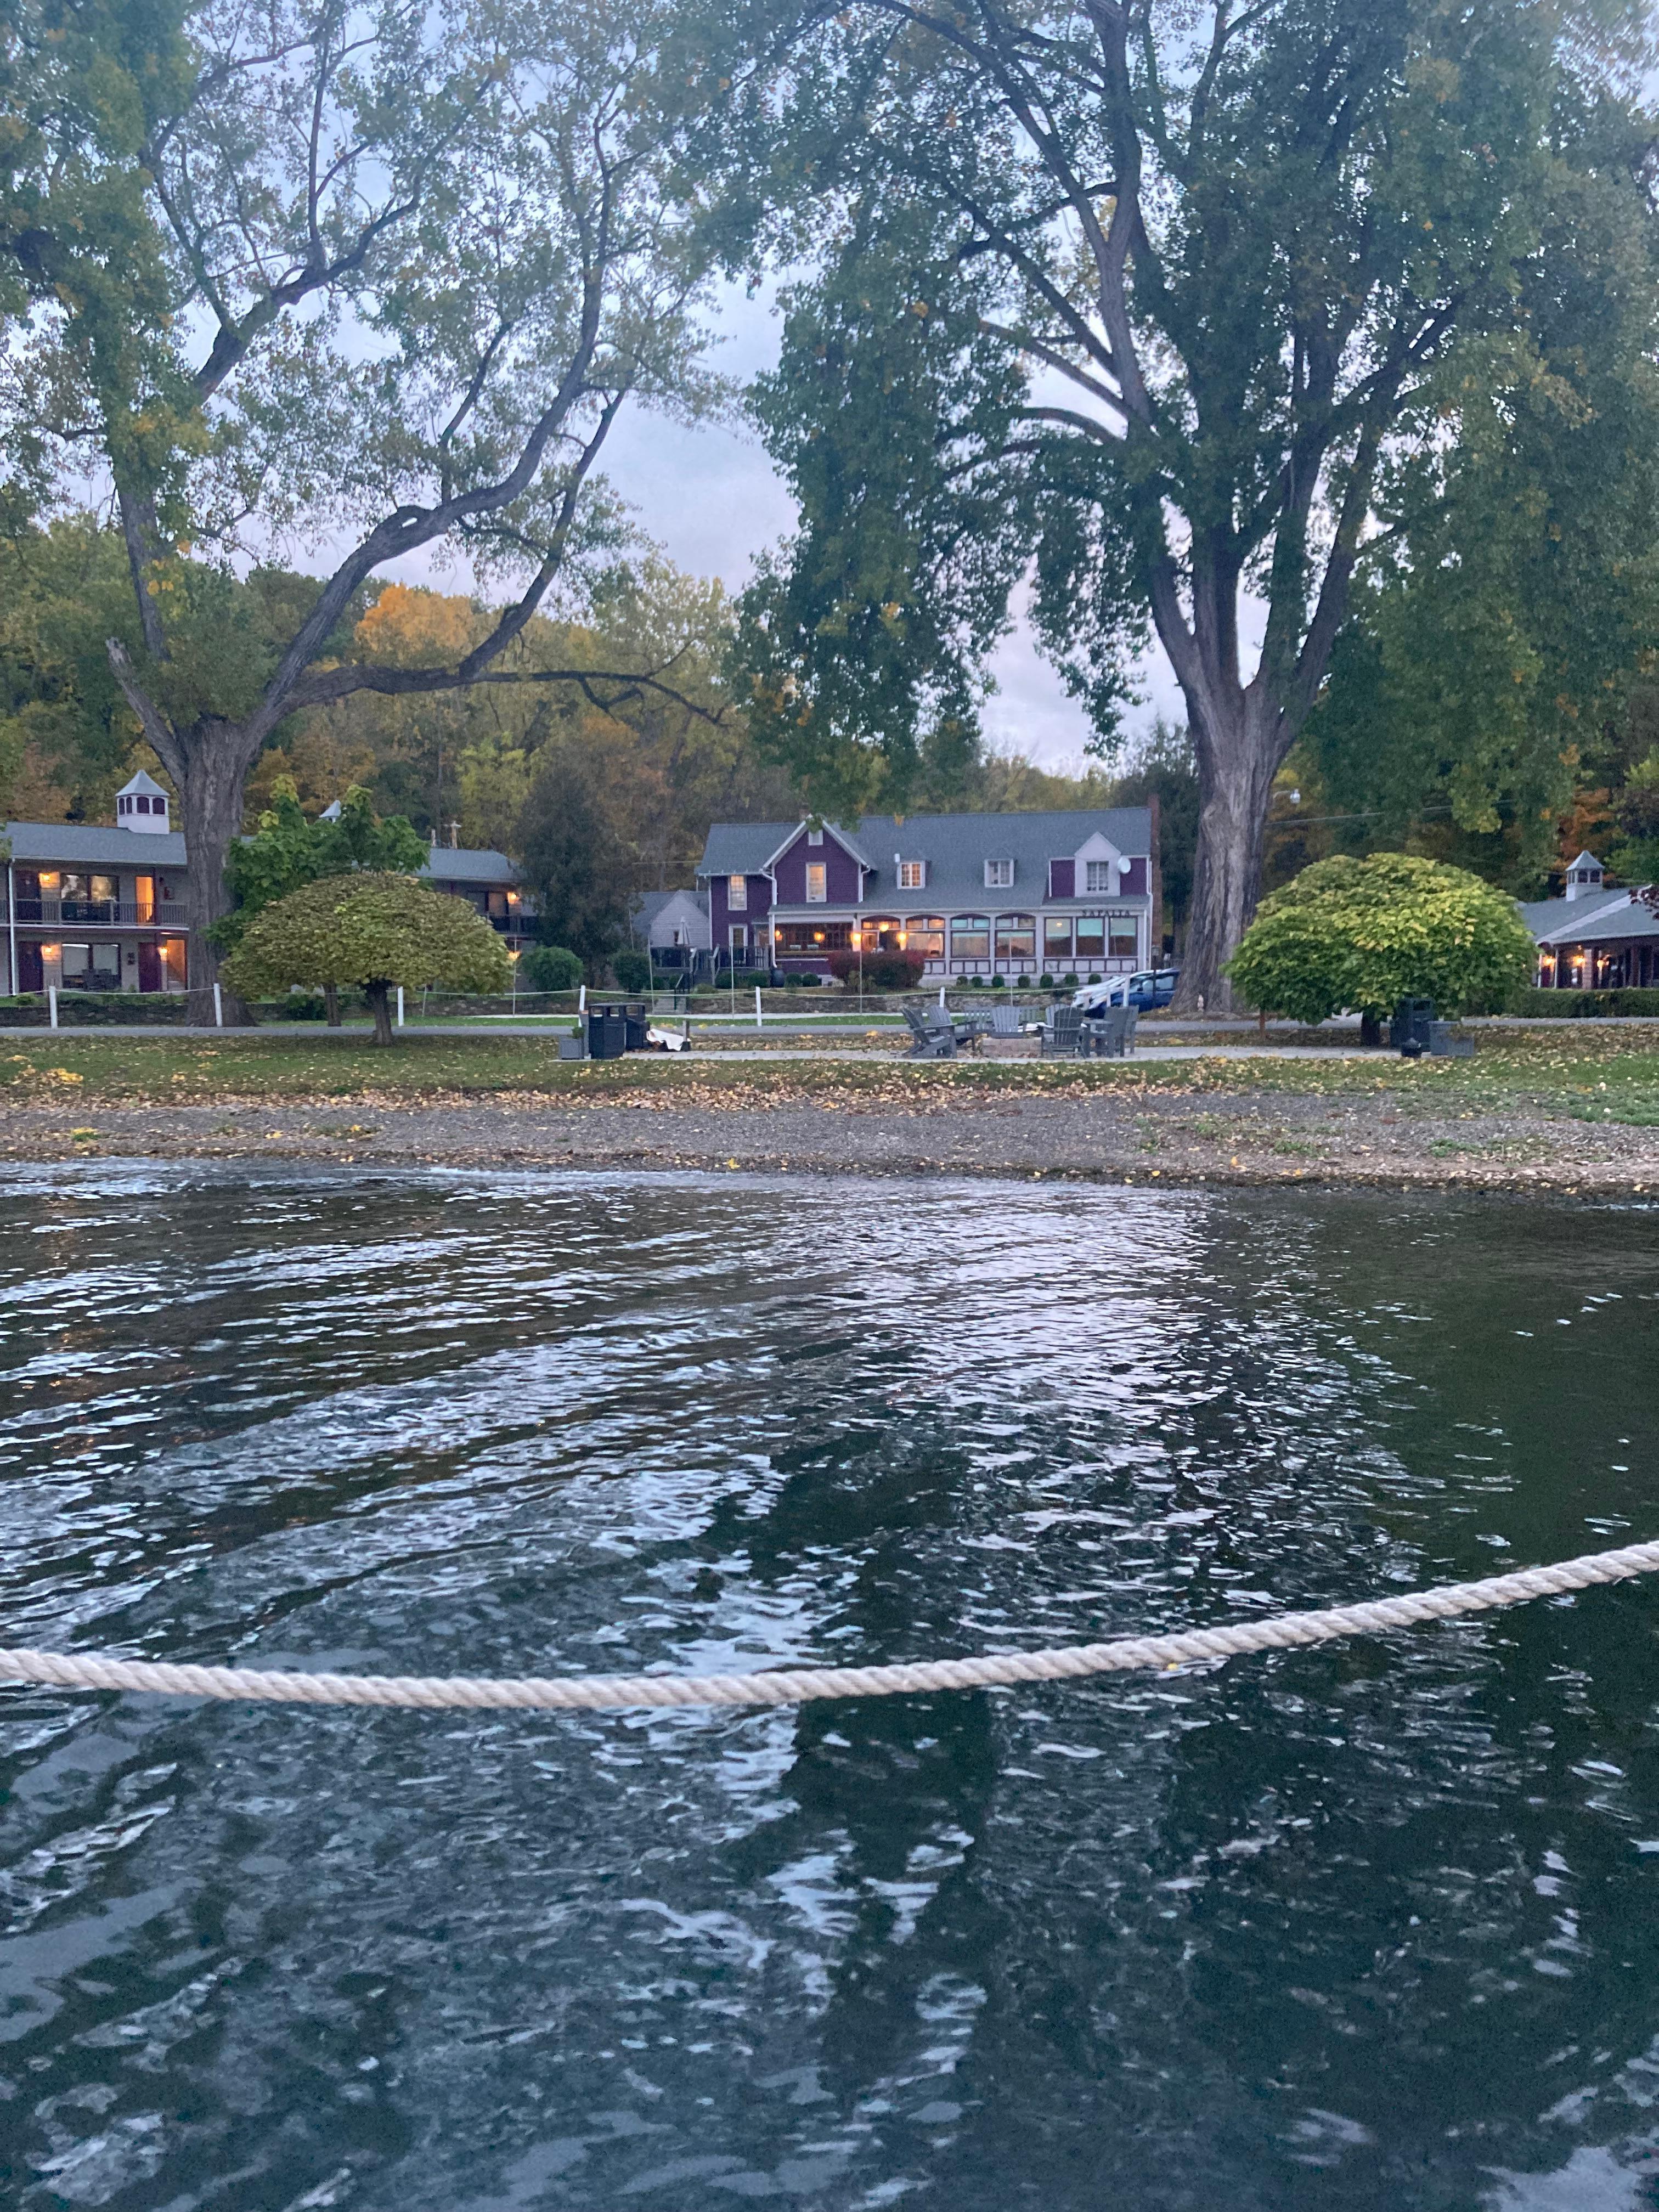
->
xmin=697 ymin=808 xmax=1161 ymax=982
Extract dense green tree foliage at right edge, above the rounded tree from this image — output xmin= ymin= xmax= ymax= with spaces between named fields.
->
xmin=1301 ymin=113 xmax=1659 ymax=896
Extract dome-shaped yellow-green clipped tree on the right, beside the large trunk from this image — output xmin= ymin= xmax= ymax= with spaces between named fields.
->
xmin=1230 ymin=851 xmax=1533 ymax=1022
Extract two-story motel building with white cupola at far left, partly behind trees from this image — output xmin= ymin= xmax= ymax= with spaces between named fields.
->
xmin=0 ymin=770 xmax=535 ymax=995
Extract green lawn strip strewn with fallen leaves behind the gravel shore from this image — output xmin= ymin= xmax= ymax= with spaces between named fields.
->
xmin=0 ymin=1022 xmax=1659 ymax=1128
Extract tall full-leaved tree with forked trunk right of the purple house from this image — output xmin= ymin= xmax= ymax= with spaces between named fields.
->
xmin=739 ymin=0 xmax=1652 ymax=1005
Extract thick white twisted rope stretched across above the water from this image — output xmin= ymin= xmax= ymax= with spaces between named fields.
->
xmin=0 ymin=1544 xmax=1659 ymax=1712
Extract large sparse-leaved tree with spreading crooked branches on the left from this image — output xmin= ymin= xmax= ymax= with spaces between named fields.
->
xmin=0 ymin=0 xmax=738 ymax=1017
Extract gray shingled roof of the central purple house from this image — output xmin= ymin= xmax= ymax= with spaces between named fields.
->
xmin=697 ymin=808 xmax=1153 ymax=911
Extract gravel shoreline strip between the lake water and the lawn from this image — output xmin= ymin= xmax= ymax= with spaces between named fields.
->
xmin=0 ymin=1086 xmax=1659 ymax=1197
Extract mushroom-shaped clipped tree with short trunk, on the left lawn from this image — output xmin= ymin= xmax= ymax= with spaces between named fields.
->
xmin=225 ymin=872 xmax=509 ymax=1044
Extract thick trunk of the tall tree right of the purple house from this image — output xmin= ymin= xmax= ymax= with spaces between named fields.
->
xmin=1175 ymin=684 xmax=1294 ymax=1013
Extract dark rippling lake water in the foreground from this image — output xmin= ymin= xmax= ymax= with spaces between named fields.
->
xmin=0 ymin=1161 xmax=1659 ymax=2212
